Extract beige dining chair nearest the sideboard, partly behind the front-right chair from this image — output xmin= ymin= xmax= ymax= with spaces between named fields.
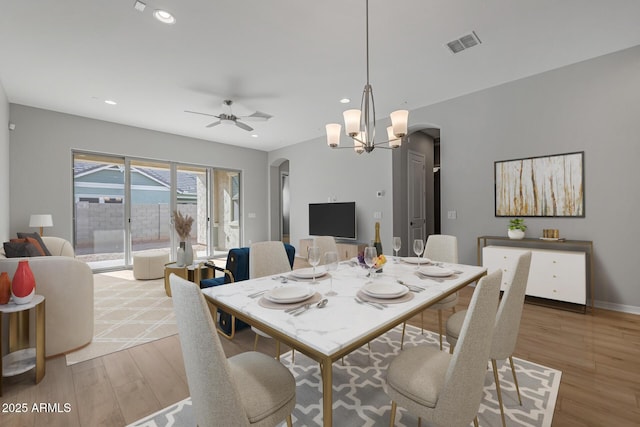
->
xmin=447 ymin=251 xmax=531 ymax=426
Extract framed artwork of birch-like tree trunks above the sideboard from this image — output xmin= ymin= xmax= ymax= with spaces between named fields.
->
xmin=494 ymin=151 xmax=584 ymax=217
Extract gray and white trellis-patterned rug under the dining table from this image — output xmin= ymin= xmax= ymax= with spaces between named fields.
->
xmin=131 ymin=325 xmax=562 ymax=427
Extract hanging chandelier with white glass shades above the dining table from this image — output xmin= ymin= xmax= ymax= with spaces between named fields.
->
xmin=326 ymin=0 xmax=409 ymax=154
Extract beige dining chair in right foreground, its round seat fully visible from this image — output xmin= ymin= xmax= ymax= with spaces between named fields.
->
xmin=386 ymin=270 xmax=502 ymax=427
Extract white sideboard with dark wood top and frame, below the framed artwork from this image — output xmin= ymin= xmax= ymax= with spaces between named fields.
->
xmin=478 ymin=236 xmax=594 ymax=312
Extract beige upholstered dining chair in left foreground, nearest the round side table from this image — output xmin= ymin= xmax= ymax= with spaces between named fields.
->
xmin=169 ymin=274 xmax=296 ymax=427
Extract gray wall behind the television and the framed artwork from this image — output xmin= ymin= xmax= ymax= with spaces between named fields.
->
xmin=269 ymin=47 xmax=640 ymax=313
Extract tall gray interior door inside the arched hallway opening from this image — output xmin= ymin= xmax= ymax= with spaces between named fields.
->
xmin=410 ymin=150 xmax=426 ymax=251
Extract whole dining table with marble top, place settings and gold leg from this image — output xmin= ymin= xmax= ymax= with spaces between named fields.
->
xmin=202 ymin=257 xmax=487 ymax=426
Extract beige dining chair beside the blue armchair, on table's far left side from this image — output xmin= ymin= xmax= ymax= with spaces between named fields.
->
xmin=249 ymin=241 xmax=291 ymax=360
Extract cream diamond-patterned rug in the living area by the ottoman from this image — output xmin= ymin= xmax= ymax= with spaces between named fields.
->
xmin=66 ymin=270 xmax=178 ymax=366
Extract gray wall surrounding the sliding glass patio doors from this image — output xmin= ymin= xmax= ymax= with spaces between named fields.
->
xmin=8 ymin=104 xmax=268 ymax=247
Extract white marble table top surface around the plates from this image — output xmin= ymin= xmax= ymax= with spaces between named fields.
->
xmin=202 ymin=257 xmax=486 ymax=358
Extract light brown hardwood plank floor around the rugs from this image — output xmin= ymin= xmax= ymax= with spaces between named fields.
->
xmin=0 ymin=288 xmax=640 ymax=427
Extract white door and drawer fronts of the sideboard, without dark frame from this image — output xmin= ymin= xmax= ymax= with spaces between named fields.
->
xmin=482 ymin=246 xmax=587 ymax=306
